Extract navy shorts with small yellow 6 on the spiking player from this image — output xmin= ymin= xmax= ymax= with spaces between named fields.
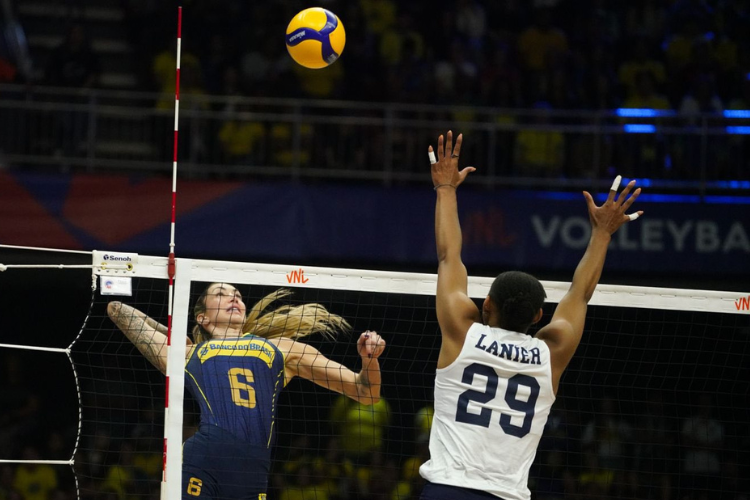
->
xmin=182 ymin=426 xmax=271 ymax=500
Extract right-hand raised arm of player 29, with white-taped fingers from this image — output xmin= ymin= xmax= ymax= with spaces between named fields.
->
xmin=536 ymin=175 xmax=643 ymax=392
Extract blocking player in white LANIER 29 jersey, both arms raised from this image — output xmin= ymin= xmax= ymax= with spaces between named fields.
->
xmin=420 ymin=132 xmax=643 ymax=500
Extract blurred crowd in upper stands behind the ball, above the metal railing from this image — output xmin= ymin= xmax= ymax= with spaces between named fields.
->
xmin=108 ymin=0 xmax=750 ymax=112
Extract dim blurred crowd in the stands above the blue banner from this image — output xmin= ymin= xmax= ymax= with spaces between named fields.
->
xmin=0 ymin=0 xmax=750 ymax=180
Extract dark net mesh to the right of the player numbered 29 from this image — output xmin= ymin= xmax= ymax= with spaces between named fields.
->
xmin=533 ymin=306 xmax=750 ymax=499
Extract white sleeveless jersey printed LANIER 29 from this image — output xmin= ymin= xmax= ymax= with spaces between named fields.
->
xmin=419 ymin=323 xmax=555 ymax=500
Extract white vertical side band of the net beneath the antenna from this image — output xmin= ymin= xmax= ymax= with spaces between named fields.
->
xmin=161 ymin=259 xmax=192 ymax=500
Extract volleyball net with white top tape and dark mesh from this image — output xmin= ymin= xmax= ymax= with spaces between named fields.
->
xmin=0 ymin=252 xmax=750 ymax=500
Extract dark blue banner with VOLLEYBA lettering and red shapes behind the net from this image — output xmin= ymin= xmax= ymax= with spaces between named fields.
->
xmin=0 ymin=173 xmax=750 ymax=275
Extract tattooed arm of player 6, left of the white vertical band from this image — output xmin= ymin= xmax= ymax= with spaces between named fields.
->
xmin=107 ymin=302 xmax=189 ymax=374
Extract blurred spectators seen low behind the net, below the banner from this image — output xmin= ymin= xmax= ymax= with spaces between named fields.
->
xmin=0 ymin=370 xmax=750 ymax=500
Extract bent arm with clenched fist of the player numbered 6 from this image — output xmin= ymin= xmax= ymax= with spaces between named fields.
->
xmin=272 ymin=331 xmax=385 ymax=405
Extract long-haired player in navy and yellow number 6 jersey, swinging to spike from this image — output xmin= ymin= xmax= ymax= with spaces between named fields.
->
xmin=107 ymin=283 xmax=385 ymax=500
